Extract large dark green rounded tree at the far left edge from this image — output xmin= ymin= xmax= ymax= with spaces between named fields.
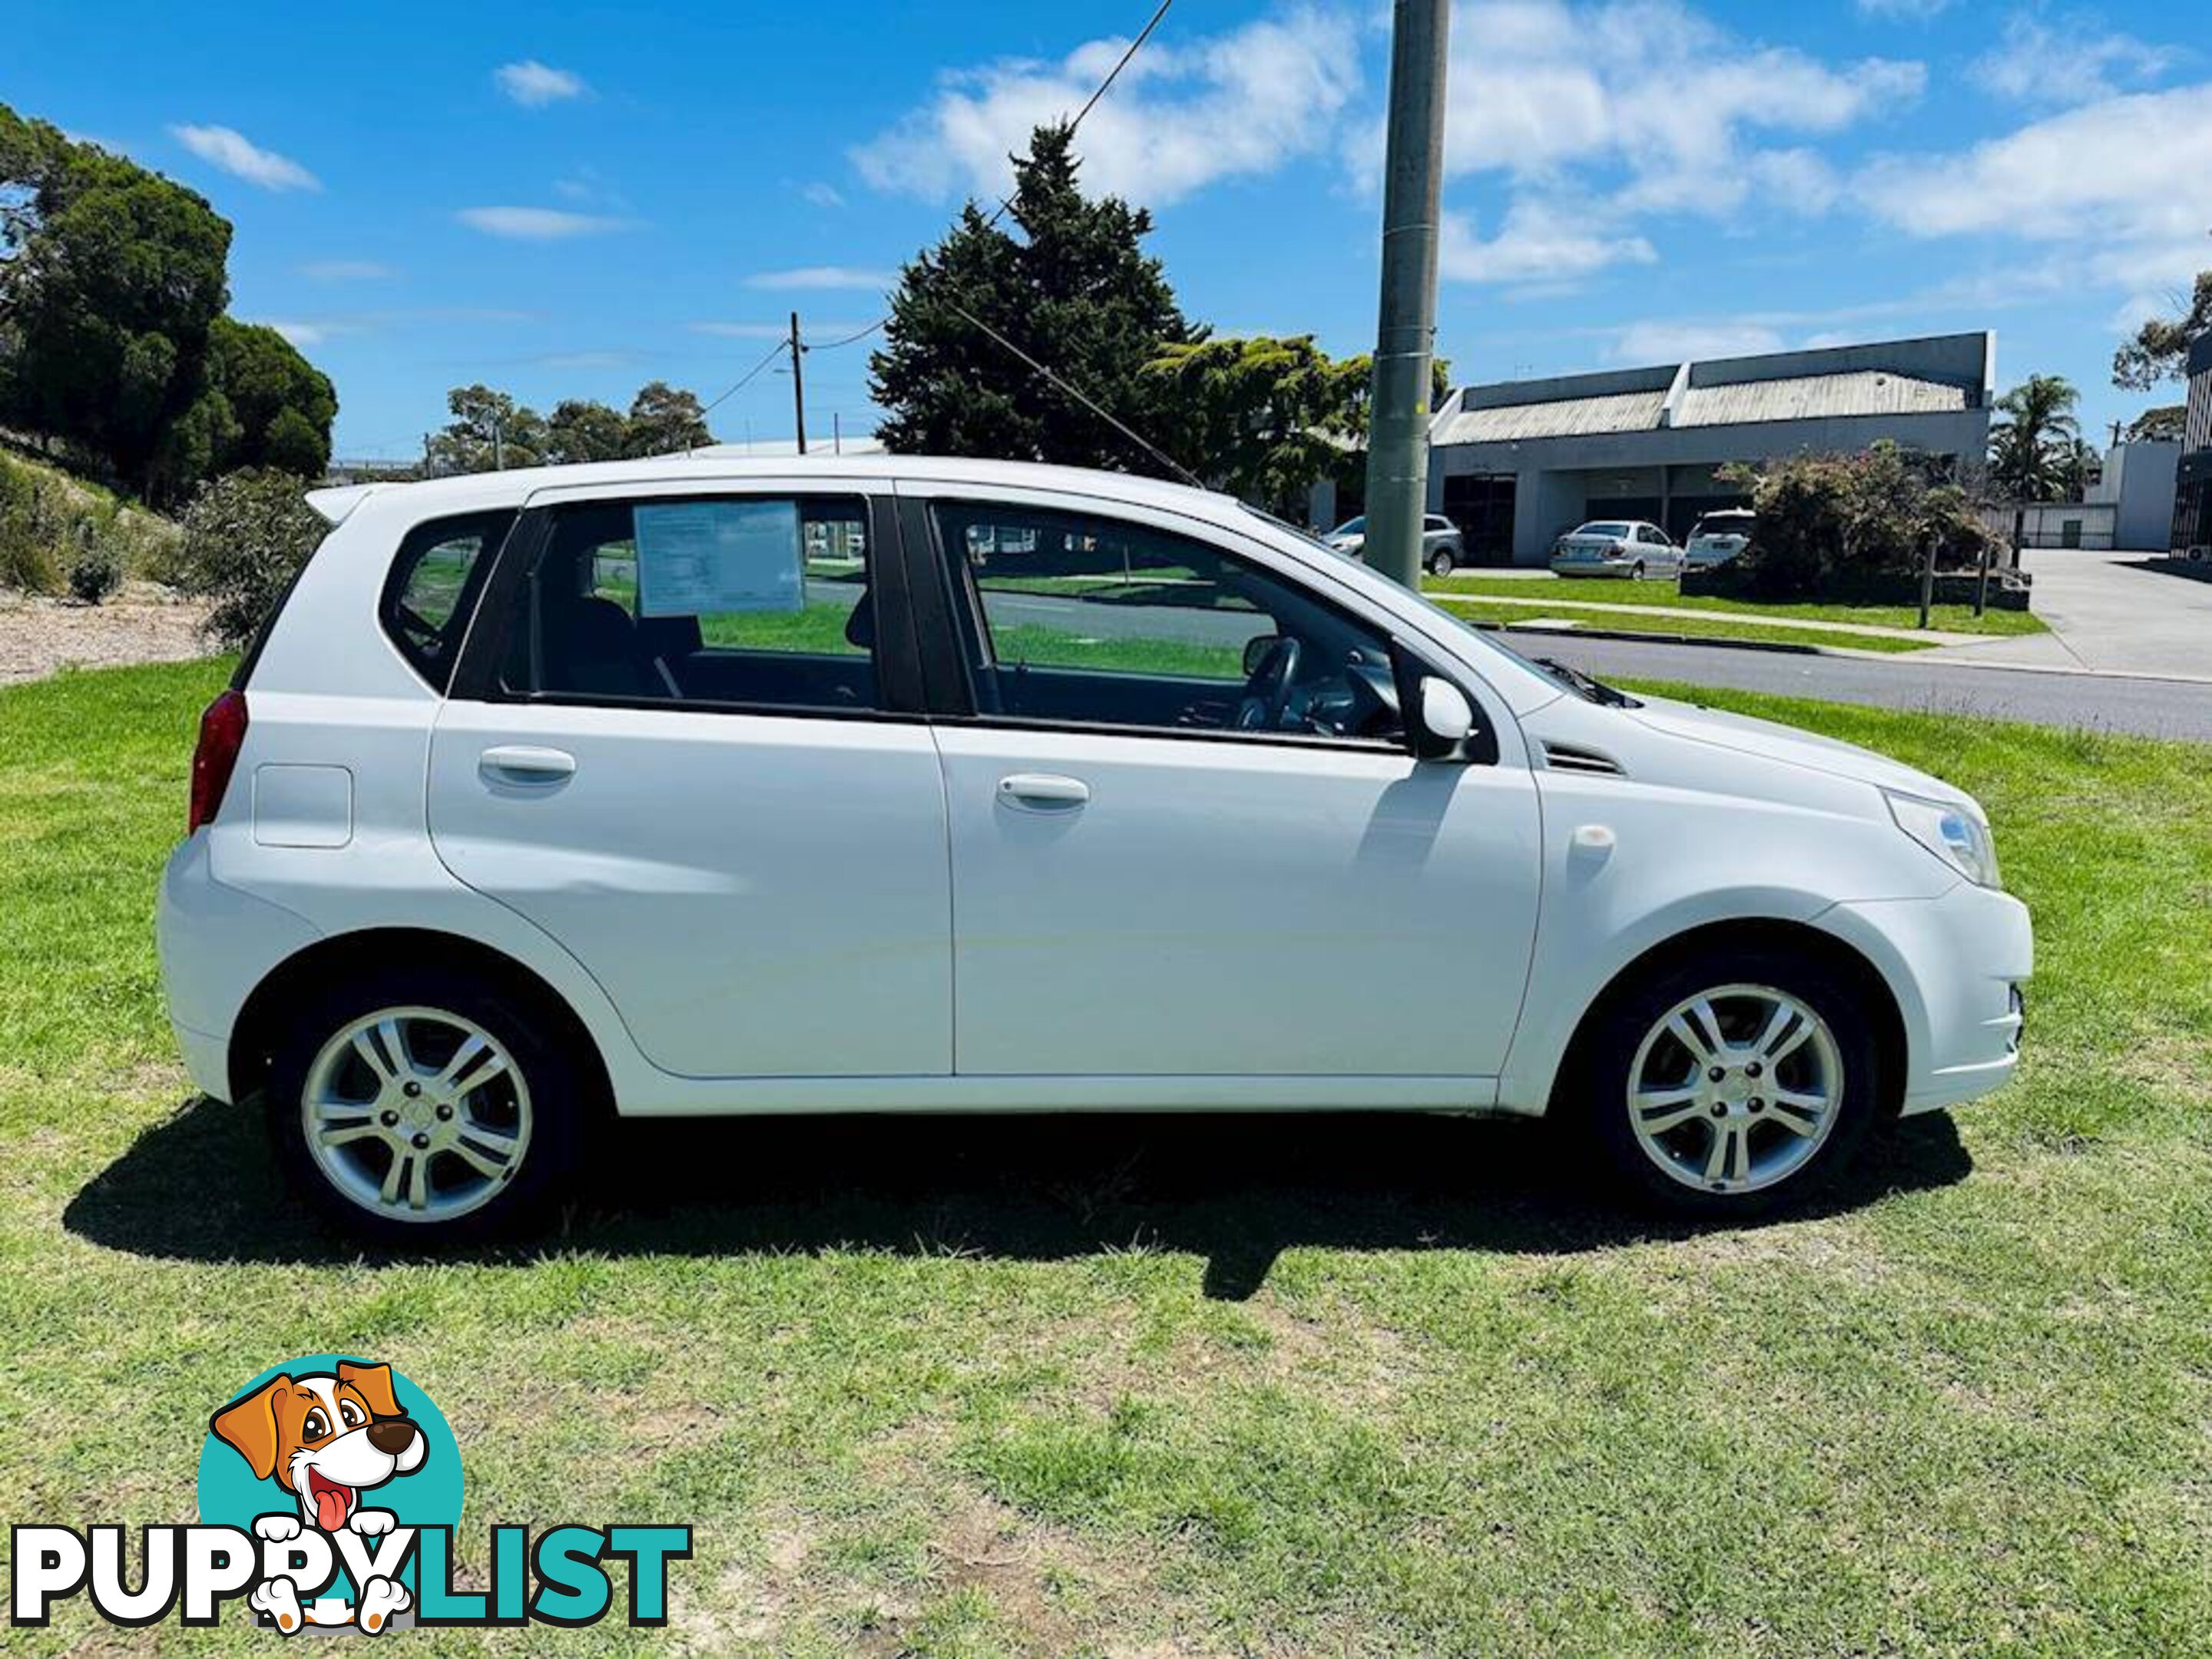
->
xmin=0 ymin=106 xmax=230 ymax=495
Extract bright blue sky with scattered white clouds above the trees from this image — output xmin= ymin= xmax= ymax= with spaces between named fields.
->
xmin=0 ymin=0 xmax=2212 ymax=455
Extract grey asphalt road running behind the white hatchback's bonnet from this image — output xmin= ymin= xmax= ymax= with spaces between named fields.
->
xmin=1511 ymin=635 xmax=2212 ymax=743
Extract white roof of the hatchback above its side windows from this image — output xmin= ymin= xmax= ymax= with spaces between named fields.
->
xmin=307 ymin=455 xmax=1241 ymax=525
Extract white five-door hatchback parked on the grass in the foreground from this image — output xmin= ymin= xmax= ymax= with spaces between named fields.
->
xmin=159 ymin=455 xmax=2031 ymax=1237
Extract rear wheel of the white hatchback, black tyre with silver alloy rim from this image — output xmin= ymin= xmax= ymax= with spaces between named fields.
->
xmin=266 ymin=969 xmax=595 ymax=1245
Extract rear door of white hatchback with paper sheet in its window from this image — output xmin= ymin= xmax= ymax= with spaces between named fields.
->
xmin=429 ymin=482 xmax=951 ymax=1078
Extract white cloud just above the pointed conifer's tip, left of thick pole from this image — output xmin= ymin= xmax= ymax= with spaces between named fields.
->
xmin=852 ymin=7 xmax=1360 ymax=206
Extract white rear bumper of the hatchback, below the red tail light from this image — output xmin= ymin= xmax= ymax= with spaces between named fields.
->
xmin=155 ymin=832 xmax=321 ymax=1099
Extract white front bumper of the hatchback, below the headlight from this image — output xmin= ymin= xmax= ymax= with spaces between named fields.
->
xmin=1820 ymin=882 xmax=2035 ymax=1115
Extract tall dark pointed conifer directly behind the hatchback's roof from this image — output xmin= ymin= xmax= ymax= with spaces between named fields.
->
xmin=869 ymin=124 xmax=1204 ymax=471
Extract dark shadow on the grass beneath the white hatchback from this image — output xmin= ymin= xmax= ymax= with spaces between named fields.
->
xmin=65 ymin=1097 xmax=1973 ymax=1300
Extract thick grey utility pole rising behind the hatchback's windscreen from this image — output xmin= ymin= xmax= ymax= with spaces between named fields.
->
xmin=1367 ymin=0 xmax=1451 ymax=588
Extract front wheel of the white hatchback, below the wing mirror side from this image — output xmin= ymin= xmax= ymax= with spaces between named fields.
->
xmin=1555 ymin=947 xmax=1885 ymax=1219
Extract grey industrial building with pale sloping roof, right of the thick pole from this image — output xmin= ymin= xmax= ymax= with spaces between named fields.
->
xmin=1429 ymin=332 xmax=2008 ymax=564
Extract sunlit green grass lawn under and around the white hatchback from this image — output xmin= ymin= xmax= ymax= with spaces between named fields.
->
xmin=0 ymin=661 xmax=2212 ymax=1659
